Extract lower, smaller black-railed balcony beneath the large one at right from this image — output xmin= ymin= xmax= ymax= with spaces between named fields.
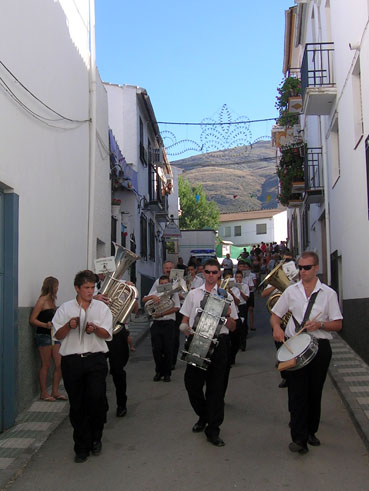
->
xmin=304 ymin=147 xmax=324 ymax=204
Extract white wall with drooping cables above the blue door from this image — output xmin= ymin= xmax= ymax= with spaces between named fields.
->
xmin=0 ymin=0 xmax=110 ymax=306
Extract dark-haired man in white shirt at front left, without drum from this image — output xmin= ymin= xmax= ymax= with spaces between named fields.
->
xmin=52 ymin=270 xmax=113 ymax=463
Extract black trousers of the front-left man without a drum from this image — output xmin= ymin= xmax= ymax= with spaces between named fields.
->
xmin=61 ymin=353 xmax=108 ymax=454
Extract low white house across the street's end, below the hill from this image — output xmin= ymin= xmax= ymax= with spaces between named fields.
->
xmin=218 ymin=209 xmax=287 ymax=247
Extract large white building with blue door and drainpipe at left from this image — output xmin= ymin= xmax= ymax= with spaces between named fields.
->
xmin=0 ymin=0 xmax=111 ymax=431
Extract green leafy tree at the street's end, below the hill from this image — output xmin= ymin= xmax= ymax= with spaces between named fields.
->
xmin=178 ymin=176 xmax=219 ymax=230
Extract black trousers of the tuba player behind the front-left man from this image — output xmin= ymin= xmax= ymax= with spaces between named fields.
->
xmin=106 ymin=327 xmax=129 ymax=407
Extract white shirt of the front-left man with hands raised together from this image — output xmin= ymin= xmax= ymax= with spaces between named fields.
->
xmin=51 ymin=299 xmax=113 ymax=356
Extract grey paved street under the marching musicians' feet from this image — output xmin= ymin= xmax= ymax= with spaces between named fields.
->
xmin=2 ymin=299 xmax=369 ymax=491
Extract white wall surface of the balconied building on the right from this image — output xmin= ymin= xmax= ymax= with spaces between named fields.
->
xmin=305 ymin=0 xmax=369 ymax=299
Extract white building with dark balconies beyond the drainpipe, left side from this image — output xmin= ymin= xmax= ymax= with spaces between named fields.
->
xmin=105 ymin=83 xmax=173 ymax=297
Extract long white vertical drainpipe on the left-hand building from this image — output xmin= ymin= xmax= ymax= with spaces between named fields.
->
xmin=87 ymin=0 xmax=96 ymax=269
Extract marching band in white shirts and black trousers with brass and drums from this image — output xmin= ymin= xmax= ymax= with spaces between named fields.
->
xmin=52 ymin=250 xmax=342 ymax=463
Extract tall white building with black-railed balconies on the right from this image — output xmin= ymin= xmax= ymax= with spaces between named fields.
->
xmin=278 ymin=0 xmax=369 ymax=362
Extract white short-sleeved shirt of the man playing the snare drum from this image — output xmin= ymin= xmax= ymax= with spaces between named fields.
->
xmin=272 ymin=279 xmax=342 ymax=339
